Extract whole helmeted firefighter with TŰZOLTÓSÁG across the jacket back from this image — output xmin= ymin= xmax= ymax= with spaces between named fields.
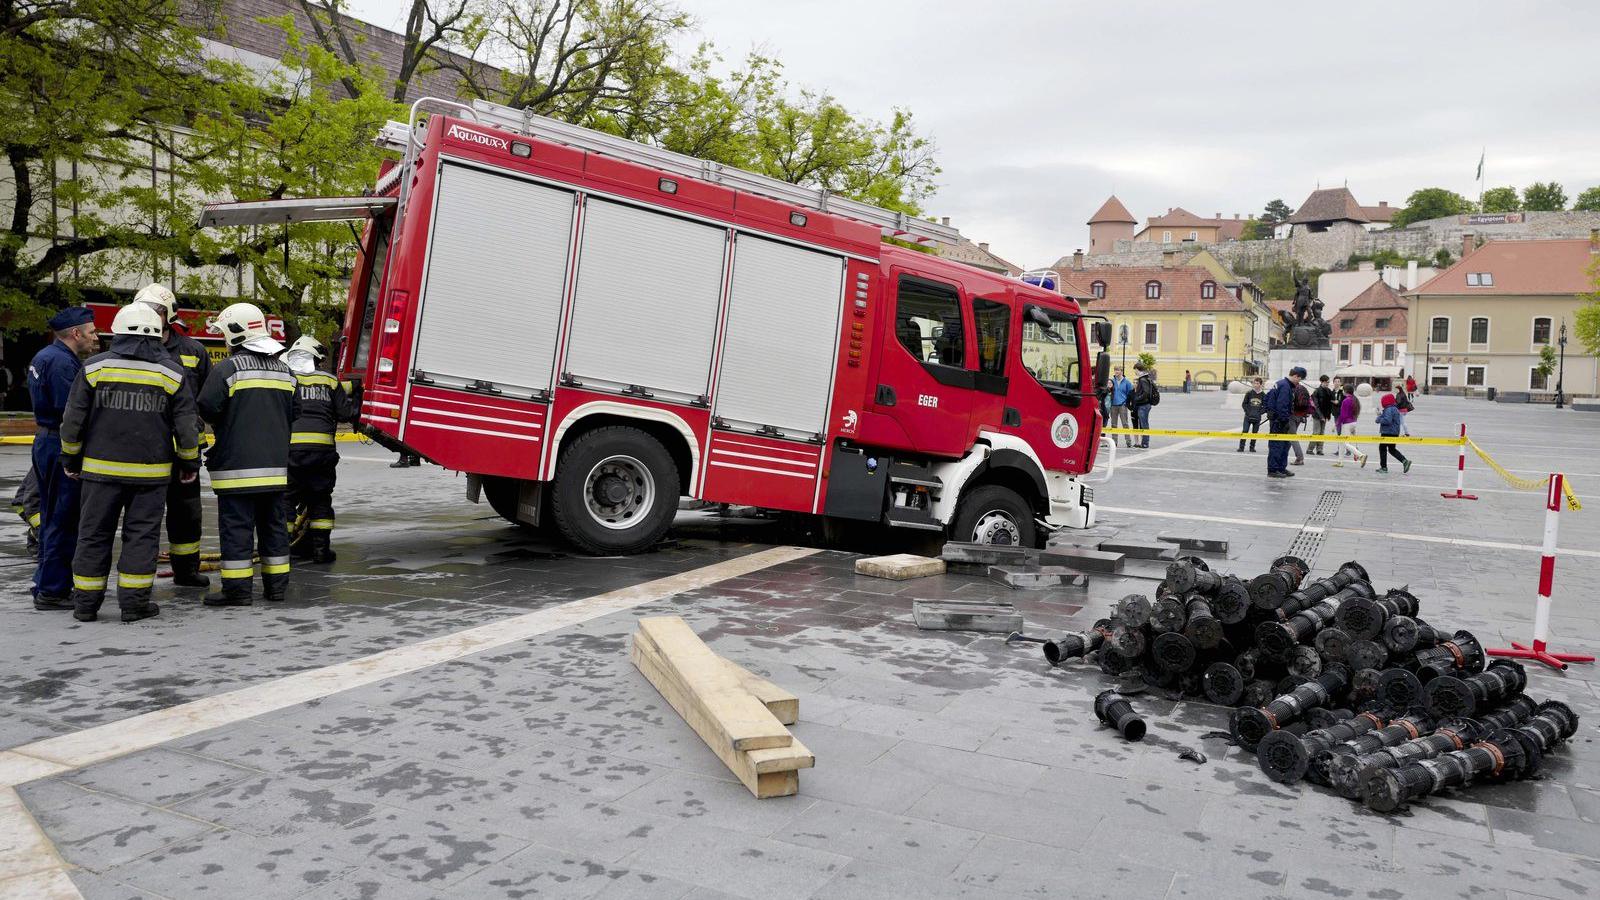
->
xmin=61 ymin=303 xmax=200 ymax=621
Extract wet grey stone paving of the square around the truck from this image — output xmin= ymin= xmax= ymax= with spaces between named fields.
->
xmin=0 ymin=394 xmax=1600 ymax=900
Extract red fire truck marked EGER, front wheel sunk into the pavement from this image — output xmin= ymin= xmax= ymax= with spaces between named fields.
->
xmin=202 ymin=101 xmax=1110 ymax=552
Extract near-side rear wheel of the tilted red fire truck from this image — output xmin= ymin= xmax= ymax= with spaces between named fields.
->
xmin=550 ymin=424 xmax=678 ymax=556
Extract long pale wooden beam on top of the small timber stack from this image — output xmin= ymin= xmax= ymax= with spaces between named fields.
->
xmin=638 ymin=615 xmax=794 ymax=749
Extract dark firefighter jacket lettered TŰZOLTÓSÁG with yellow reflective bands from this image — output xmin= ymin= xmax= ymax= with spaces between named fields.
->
xmin=61 ymin=335 xmax=200 ymax=484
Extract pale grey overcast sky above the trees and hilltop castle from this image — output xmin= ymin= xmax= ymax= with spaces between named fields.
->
xmin=337 ymin=0 xmax=1600 ymax=266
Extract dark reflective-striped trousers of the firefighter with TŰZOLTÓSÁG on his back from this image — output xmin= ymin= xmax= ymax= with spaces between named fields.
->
xmin=72 ymin=480 xmax=166 ymax=612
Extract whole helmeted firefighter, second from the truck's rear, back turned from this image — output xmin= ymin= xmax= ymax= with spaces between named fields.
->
xmin=198 ymin=303 xmax=298 ymax=607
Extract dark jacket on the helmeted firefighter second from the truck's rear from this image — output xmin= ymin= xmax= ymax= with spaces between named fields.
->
xmin=200 ymin=348 xmax=299 ymax=493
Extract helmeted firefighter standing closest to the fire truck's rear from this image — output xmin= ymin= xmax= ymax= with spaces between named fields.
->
xmin=283 ymin=335 xmax=355 ymax=562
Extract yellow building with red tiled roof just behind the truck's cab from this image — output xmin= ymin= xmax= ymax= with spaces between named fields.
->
xmin=1062 ymin=253 xmax=1270 ymax=381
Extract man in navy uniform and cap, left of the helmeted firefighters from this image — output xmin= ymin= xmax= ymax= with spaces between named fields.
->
xmin=27 ymin=306 xmax=99 ymax=610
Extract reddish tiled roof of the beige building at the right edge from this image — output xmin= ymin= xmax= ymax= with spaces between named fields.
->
xmin=1413 ymin=239 xmax=1600 ymax=296
